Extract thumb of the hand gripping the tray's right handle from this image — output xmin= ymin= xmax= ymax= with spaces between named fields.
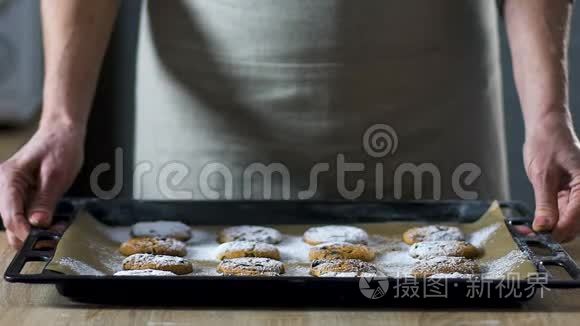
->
xmin=532 ymin=173 xmax=559 ymax=232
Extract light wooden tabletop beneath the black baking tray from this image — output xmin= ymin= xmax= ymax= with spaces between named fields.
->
xmin=0 ymin=232 xmax=580 ymax=326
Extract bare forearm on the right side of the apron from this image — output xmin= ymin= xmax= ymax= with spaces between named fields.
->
xmin=504 ymin=0 xmax=572 ymax=134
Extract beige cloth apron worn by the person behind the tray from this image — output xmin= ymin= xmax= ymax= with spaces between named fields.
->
xmin=134 ymin=0 xmax=508 ymax=199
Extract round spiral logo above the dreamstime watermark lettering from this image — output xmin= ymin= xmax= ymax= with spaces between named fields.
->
xmin=363 ymin=124 xmax=399 ymax=158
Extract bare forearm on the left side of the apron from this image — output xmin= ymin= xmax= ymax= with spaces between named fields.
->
xmin=41 ymin=0 xmax=119 ymax=129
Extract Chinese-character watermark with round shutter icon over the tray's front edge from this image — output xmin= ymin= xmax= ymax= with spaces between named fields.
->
xmin=359 ymin=273 xmax=550 ymax=300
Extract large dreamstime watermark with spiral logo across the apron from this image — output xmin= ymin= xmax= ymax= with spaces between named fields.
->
xmin=90 ymin=124 xmax=482 ymax=200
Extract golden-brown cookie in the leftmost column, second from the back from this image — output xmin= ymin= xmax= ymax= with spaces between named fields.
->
xmin=119 ymin=238 xmax=187 ymax=257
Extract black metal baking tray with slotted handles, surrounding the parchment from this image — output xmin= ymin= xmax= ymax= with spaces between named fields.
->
xmin=4 ymin=199 xmax=580 ymax=307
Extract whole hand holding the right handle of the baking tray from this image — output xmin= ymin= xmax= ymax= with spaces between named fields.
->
xmin=524 ymin=113 xmax=580 ymax=242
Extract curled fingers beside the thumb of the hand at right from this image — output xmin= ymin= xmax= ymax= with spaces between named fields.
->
xmin=552 ymin=179 xmax=580 ymax=242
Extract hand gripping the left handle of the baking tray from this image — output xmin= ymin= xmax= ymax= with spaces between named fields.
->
xmin=0 ymin=123 xmax=85 ymax=248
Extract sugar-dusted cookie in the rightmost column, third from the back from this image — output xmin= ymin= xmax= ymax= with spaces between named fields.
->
xmin=411 ymin=257 xmax=481 ymax=278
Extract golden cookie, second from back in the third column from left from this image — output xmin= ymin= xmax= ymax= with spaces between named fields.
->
xmin=308 ymin=242 xmax=375 ymax=261
